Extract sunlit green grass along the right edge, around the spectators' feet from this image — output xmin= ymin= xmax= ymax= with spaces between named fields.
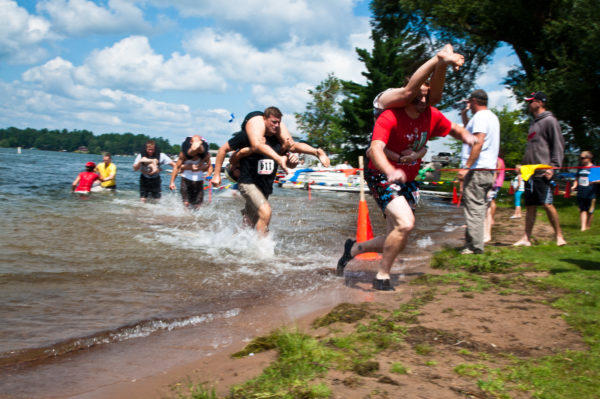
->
xmin=433 ymin=198 xmax=600 ymax=399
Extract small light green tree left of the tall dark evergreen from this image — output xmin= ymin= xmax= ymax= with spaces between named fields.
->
xmin=294 ymin=73 xmax=344 ymax=154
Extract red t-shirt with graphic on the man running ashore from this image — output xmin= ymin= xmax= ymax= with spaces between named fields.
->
xmin=369 ymin=107 xmax=452 ymax=181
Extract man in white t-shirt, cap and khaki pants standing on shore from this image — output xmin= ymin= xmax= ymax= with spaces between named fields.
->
xmin=458 ymin=89 xmax=500 ymax=254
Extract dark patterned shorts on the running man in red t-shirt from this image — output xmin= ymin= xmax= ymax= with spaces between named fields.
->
xmin=365 ymin=168 xmax=419 ymax=212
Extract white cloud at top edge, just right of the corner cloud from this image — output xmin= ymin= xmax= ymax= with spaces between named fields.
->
xmin=37 ymin=0 xmax=150 ymax=36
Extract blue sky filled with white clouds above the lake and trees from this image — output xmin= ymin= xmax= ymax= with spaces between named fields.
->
xmin=0 ymin=0 xmax=518 ymax=159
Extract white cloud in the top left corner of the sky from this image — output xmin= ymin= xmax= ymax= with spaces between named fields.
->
xmin=0 ymin=0 xmax=52 ymax=64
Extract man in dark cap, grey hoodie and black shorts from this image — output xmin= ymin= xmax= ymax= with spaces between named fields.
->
xmin=513 ymin=91 xmax=567 ymax=247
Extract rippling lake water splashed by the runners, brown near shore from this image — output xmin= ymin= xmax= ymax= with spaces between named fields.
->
xmin=0 ymin=148 xmax=462 ymax=372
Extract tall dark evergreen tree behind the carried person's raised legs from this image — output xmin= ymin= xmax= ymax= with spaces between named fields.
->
xmin=341 ymin=0 xmax=493 ymax=161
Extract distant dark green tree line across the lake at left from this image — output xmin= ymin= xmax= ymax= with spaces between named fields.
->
xmin=0 ymin=127 xmax=181 ymax=155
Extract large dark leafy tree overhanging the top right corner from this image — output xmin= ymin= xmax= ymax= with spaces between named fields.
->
xmin=380 ymin=0 xmax=600 ymax=152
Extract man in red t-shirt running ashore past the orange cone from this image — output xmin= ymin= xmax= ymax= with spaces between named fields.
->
xmin=338 ymin=85 xmax=473 ymax=291
